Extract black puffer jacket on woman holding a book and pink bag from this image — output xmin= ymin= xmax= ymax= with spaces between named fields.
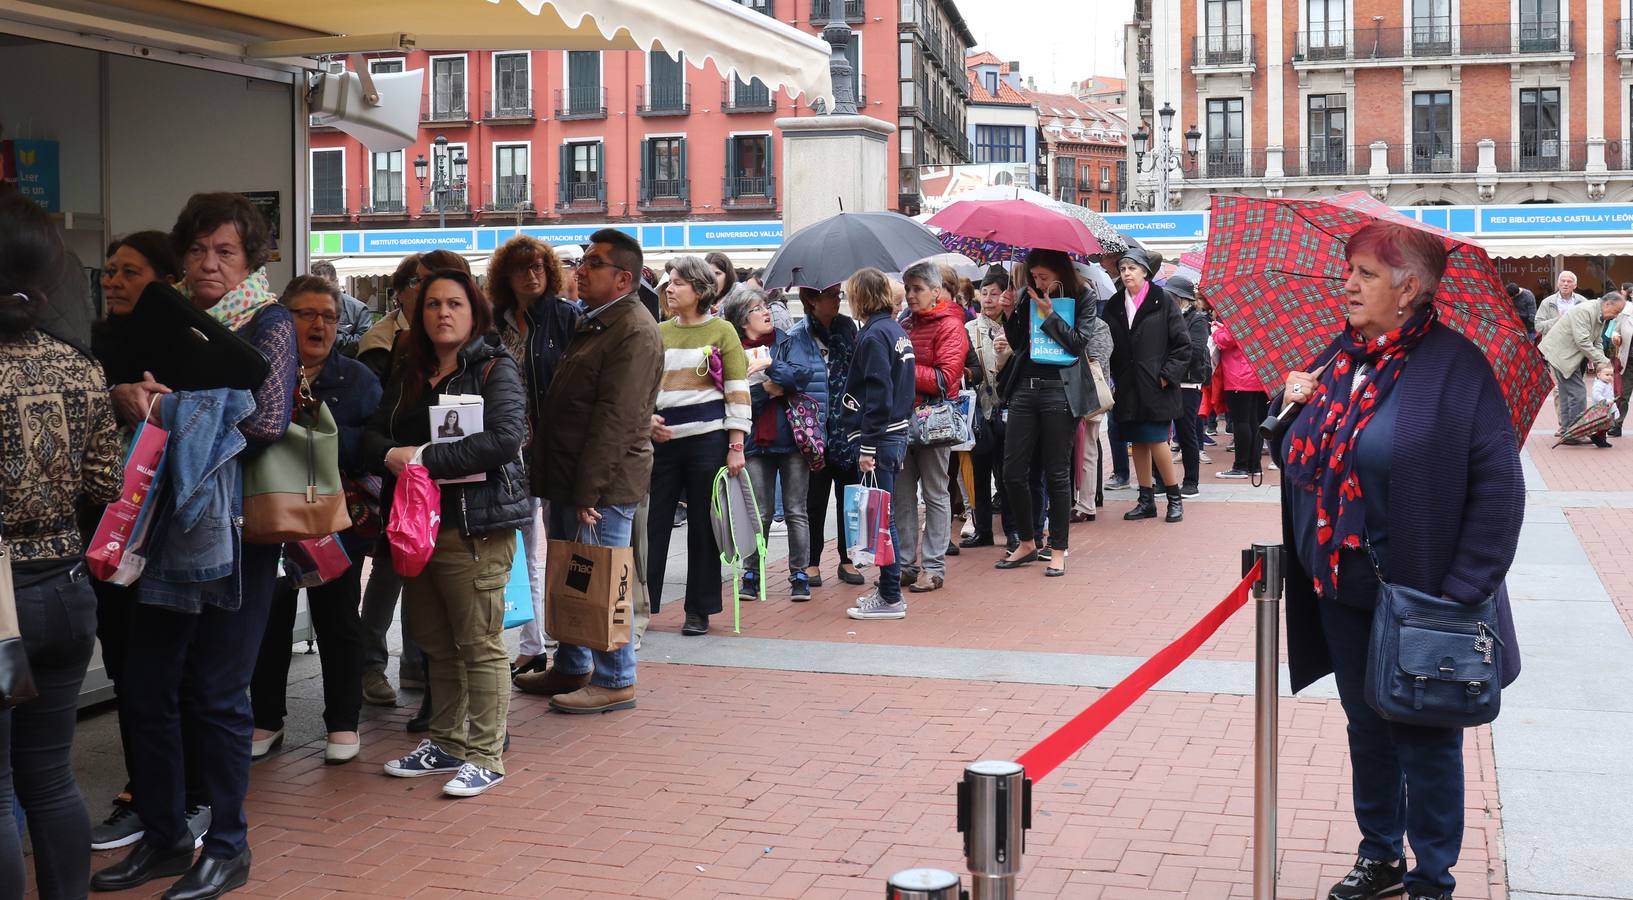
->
xmin=363 ymin=336 xmax=532 ymax=534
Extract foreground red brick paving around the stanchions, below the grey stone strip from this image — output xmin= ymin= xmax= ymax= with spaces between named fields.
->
xmin=79 ymin=665 xmax=1504 ymax=900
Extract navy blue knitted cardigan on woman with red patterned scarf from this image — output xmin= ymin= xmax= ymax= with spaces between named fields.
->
xmin=1272 ymin=325 xmax=1525 ymax=691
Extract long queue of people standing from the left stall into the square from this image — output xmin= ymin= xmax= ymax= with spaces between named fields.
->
xmin=0 ymin=181 xmax=1299 ymax=900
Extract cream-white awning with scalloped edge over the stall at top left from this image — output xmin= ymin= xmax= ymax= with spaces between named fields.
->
xmin=44 ymin=0 xmax=833 ymax=98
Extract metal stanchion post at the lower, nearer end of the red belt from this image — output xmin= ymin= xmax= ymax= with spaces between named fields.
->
xmin=959 ymin=760 xmax=1032 ymax=900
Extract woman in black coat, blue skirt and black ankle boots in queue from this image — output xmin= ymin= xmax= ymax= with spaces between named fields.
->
xmin=1104 ymin=247 xmax=1190 ymax=523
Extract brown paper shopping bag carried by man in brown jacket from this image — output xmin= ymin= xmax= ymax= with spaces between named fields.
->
xmin=544 ymin=541 xmax=635 ymax=650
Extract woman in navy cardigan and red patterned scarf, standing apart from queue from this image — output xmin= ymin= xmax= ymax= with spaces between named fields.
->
xmin=1273 ymin=222 xmax=1525 ymax=900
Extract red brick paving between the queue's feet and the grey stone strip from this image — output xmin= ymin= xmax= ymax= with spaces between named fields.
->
xmin=652 ymin=488 xmax=1280 ymax=660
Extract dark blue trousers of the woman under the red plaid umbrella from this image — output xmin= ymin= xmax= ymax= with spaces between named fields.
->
xmin=1319 ymin=597 xmax=1463 ymax=893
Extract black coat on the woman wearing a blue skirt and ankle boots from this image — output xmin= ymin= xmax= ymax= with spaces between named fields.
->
xmin=1106 ymin=284 xmax=1190 ymax=421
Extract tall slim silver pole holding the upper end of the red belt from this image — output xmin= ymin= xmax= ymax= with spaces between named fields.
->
xmin=1253 ymin=544 xmax=1284 ymax=900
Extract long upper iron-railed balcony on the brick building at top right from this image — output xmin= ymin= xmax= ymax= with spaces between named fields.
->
xmin=1293 ymin=20 xmax=1573 ymax=67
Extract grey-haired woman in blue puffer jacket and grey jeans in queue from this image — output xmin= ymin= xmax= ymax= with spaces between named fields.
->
xmin=720 ymin=286 xmax=828 ymax=601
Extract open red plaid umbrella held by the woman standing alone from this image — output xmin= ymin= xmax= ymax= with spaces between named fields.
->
xmin=1202 ymin=191 xmax=1553 ymax=444
